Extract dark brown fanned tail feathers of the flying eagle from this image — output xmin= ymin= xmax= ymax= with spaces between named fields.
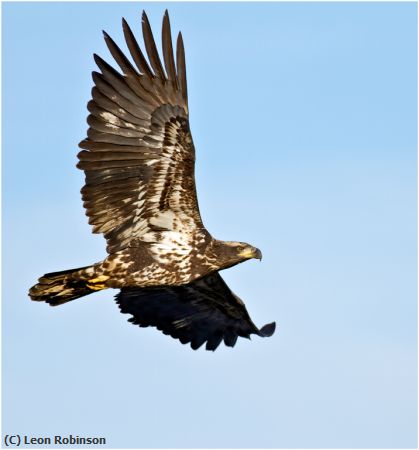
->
xmin=29 ymin=266 xmax=100 ymax=306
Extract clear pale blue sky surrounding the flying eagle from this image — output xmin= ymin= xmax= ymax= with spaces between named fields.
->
xmin=2 ymin=3 xmax=417 ymax=448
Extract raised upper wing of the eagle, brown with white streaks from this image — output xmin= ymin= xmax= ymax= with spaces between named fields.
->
xmin=77 ymin=11 xmax=203 ymax=253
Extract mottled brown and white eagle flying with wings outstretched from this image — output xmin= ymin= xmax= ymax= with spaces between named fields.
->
xmin=29 ymin=10 xmax=275 ymax=351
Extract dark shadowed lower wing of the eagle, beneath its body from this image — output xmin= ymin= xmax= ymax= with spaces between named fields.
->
xmin=116 ymin=272 xmax=275 ymax=350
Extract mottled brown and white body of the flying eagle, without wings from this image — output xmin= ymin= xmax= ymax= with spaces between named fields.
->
xmin=62 ymin=230 xmax=258 ymax=290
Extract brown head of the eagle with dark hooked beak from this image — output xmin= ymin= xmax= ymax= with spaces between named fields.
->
xmin=211 ymin=240 xmax=262 ymax=269
